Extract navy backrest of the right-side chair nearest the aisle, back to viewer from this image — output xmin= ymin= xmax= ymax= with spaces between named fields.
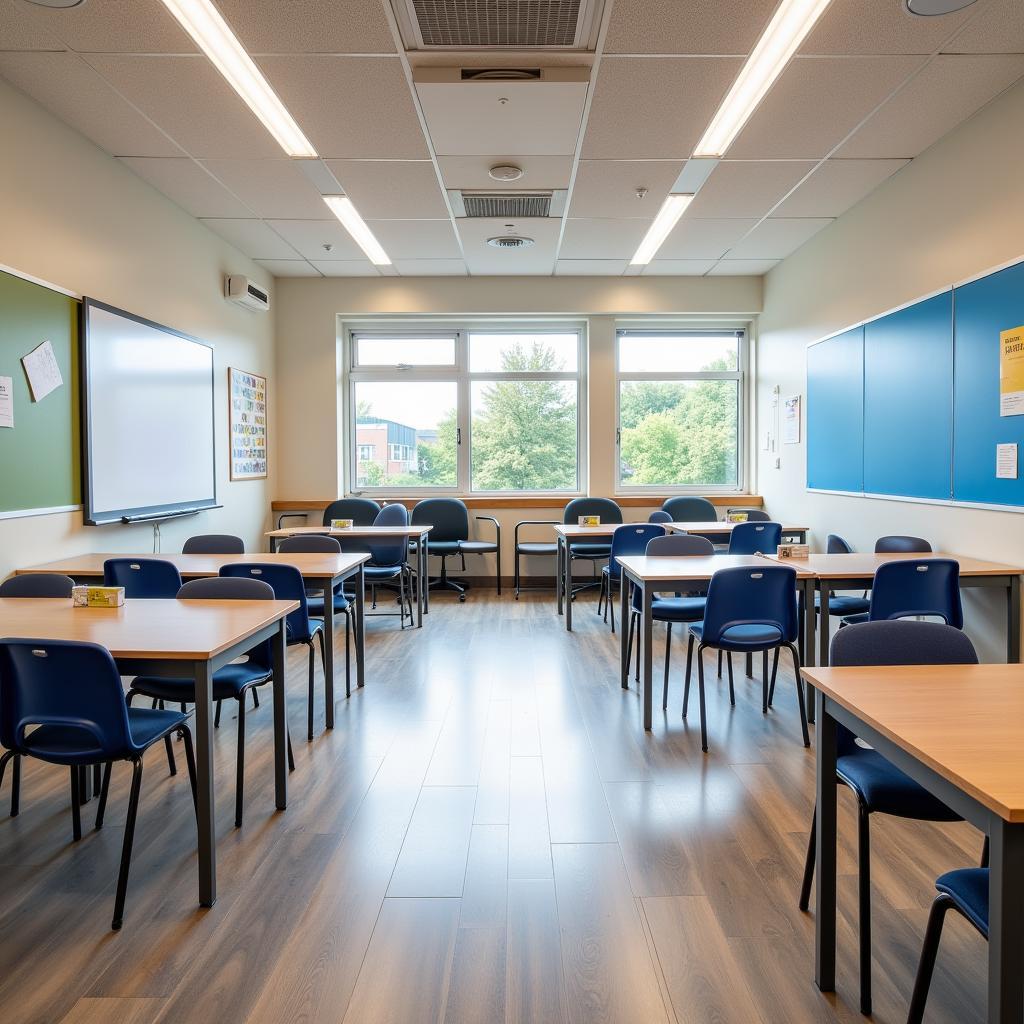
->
xmin=702 ymin=562 xmax=800 ymax=645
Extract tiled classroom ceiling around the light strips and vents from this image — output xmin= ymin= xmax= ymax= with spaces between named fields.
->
xmin=0 ymin=0 xmax=1024 ymax=276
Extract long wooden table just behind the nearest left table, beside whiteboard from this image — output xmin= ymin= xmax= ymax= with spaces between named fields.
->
xmin=14 ymin=552 xmax=370 ymax=729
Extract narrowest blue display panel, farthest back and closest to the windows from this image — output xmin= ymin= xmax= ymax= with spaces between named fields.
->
xmin=807 ymin=327 xmax=864 ymax=492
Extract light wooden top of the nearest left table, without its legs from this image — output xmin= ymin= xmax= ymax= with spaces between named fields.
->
xmin=0 ymin=597 xmax=299 ymax=662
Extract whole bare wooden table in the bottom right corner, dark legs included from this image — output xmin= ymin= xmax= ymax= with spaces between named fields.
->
xmin=804 ymin=665 xmax=1024 ymax=1024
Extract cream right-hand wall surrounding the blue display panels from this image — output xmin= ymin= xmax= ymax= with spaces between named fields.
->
xmin=757 ymin=77 xmax=1024 ymax=658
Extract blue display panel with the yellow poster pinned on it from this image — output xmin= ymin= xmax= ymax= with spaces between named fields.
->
xmin=953 ymin=263 xmax=1024 ymax=505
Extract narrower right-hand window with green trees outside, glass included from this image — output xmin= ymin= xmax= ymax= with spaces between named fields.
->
xmin=615 ymin=330 xmax=745 ymax=492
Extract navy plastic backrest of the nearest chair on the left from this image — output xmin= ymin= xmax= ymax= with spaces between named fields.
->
xmin=0 ymin=639 xmax=137 ymax=764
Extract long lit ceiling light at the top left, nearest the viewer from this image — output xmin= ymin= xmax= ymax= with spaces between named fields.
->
xmin=155 ymin=0 xmax=316 ymax=158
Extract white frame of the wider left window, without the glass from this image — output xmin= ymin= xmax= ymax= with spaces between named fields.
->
xmin=342 ymin=317 xmax=588 ymax=498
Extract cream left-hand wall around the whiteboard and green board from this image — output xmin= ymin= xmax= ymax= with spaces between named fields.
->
xmin=0 ymin=82 xmax=275 ymax=579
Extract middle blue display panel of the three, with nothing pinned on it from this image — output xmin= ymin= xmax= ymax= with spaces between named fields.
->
xmin=864 ymin=291 xmax=953 ymax=501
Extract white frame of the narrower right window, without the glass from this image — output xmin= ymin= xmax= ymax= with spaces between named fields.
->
xmin=614 ymin=322 xmax=751 ymax=497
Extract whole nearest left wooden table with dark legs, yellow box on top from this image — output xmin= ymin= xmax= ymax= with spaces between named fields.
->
xmin=0 ymin=598 xmax=298 ymax=906
